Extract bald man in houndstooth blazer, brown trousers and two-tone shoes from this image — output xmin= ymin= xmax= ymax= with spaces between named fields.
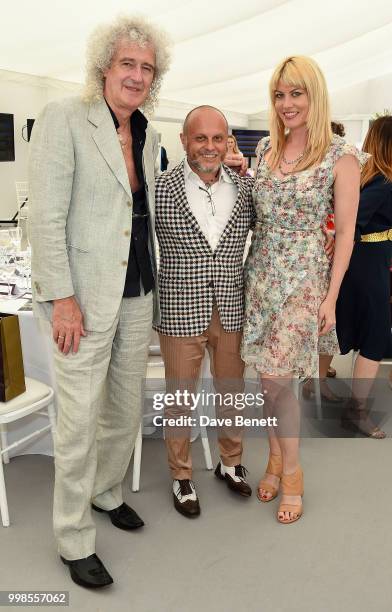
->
xmin=155 ymin=106 xmax=254 ymax=517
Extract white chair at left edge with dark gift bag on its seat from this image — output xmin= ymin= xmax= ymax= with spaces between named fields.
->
xmin=0 ymin=378 xmax=56 ymax=527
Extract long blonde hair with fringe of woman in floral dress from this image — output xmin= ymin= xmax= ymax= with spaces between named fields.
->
xmin=269 ymin=55 xmax=332 ymax=171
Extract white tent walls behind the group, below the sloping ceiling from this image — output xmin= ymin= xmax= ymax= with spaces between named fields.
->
xmin=0 ymin=70 xmax=380 ymax=219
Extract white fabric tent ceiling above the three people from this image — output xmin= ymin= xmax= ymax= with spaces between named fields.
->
xmin=0 ymin=0 xmax=392 ymax=114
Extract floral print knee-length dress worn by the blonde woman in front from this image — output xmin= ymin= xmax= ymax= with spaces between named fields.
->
xmin=241 ymin=136 xmax=368 ymax=377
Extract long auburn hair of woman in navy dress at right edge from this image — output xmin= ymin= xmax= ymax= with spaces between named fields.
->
xmin=361 ymin=115 xmax=392 ymax=187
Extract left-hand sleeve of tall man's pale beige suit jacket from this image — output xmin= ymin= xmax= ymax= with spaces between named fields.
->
xmin=29 ymin=102 xmax=75 ymax=302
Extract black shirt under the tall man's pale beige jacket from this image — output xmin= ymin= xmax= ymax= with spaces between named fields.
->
xmin=106 ymin=102 xmax=154 ymax=297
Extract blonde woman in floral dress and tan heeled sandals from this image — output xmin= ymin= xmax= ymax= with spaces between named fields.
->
xmin=242 ymin=56 xmax=362 ymax=524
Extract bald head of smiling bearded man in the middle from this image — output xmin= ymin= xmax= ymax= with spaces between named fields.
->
xmin=181 ymin=106 xmax=228 ymax=182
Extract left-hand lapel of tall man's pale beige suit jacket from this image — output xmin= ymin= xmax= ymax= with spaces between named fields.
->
xmin=87 ymin=100 xmax=132 ymax=200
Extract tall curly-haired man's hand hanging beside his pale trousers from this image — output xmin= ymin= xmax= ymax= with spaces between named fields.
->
xmin=52 ymin=295 xmax=87 ymax=355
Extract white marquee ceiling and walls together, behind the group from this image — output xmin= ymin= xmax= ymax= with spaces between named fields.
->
xmin=0 ymin=0 xmax=392 ymax=219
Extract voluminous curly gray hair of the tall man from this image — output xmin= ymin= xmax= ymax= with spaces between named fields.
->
xmin=83 ymin=15 xmax=171 ymax=114
